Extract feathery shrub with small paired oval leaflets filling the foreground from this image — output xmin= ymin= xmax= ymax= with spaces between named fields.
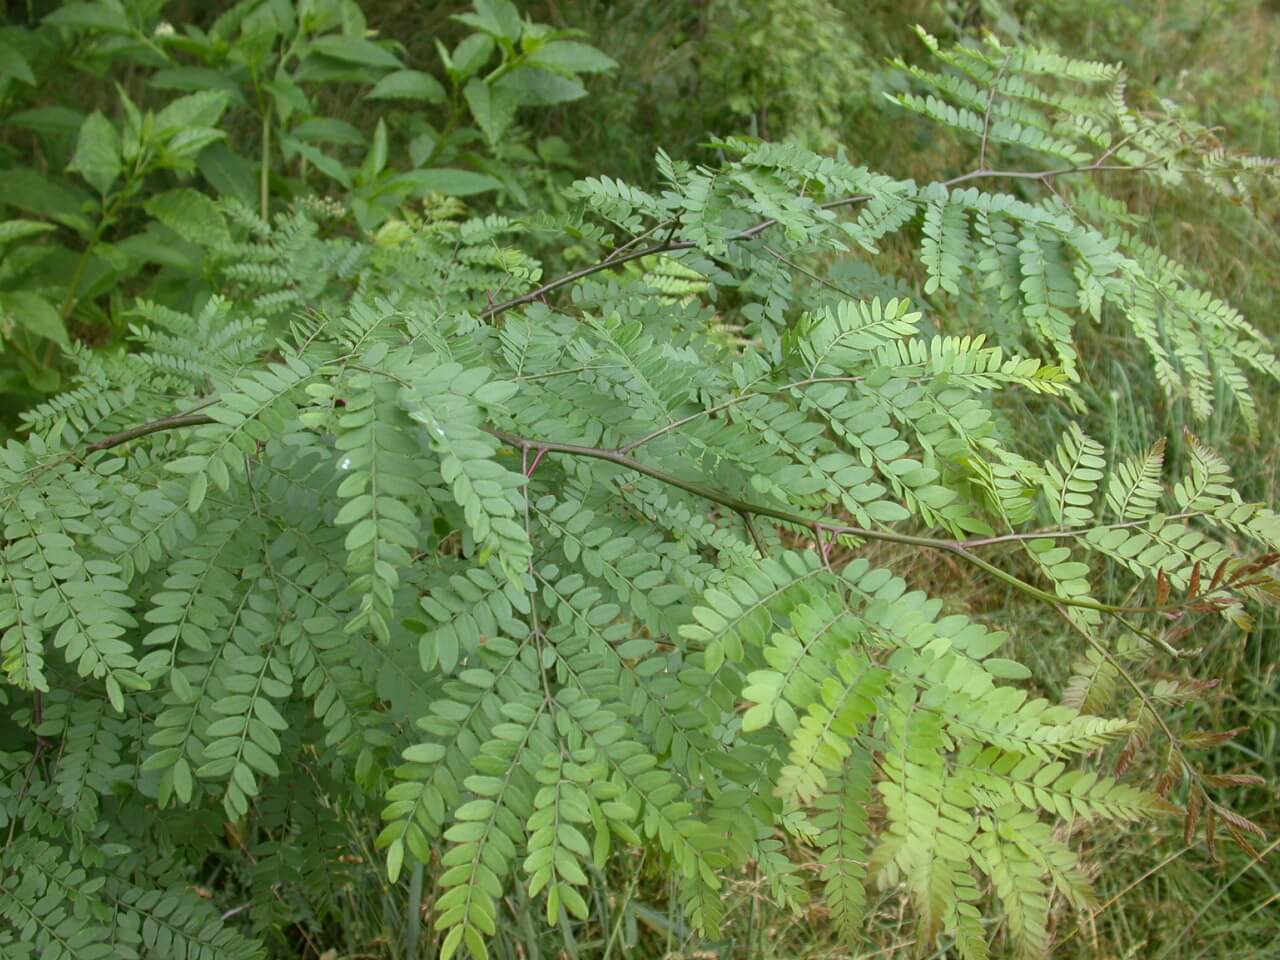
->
xmin=0 ymin=22 xmax=1280 ymax=960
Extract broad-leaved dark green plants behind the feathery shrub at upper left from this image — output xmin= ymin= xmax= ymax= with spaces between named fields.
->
xmin=0 ymin=0 xmax=616 ymax=417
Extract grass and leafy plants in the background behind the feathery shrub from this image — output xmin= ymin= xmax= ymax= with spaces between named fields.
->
xmin=0 ymin=0 xmax=1280 ymax=960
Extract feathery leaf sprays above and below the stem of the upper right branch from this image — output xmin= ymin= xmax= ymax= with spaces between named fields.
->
xmin=891 ymin=31 xmax=1276 ymax=417
